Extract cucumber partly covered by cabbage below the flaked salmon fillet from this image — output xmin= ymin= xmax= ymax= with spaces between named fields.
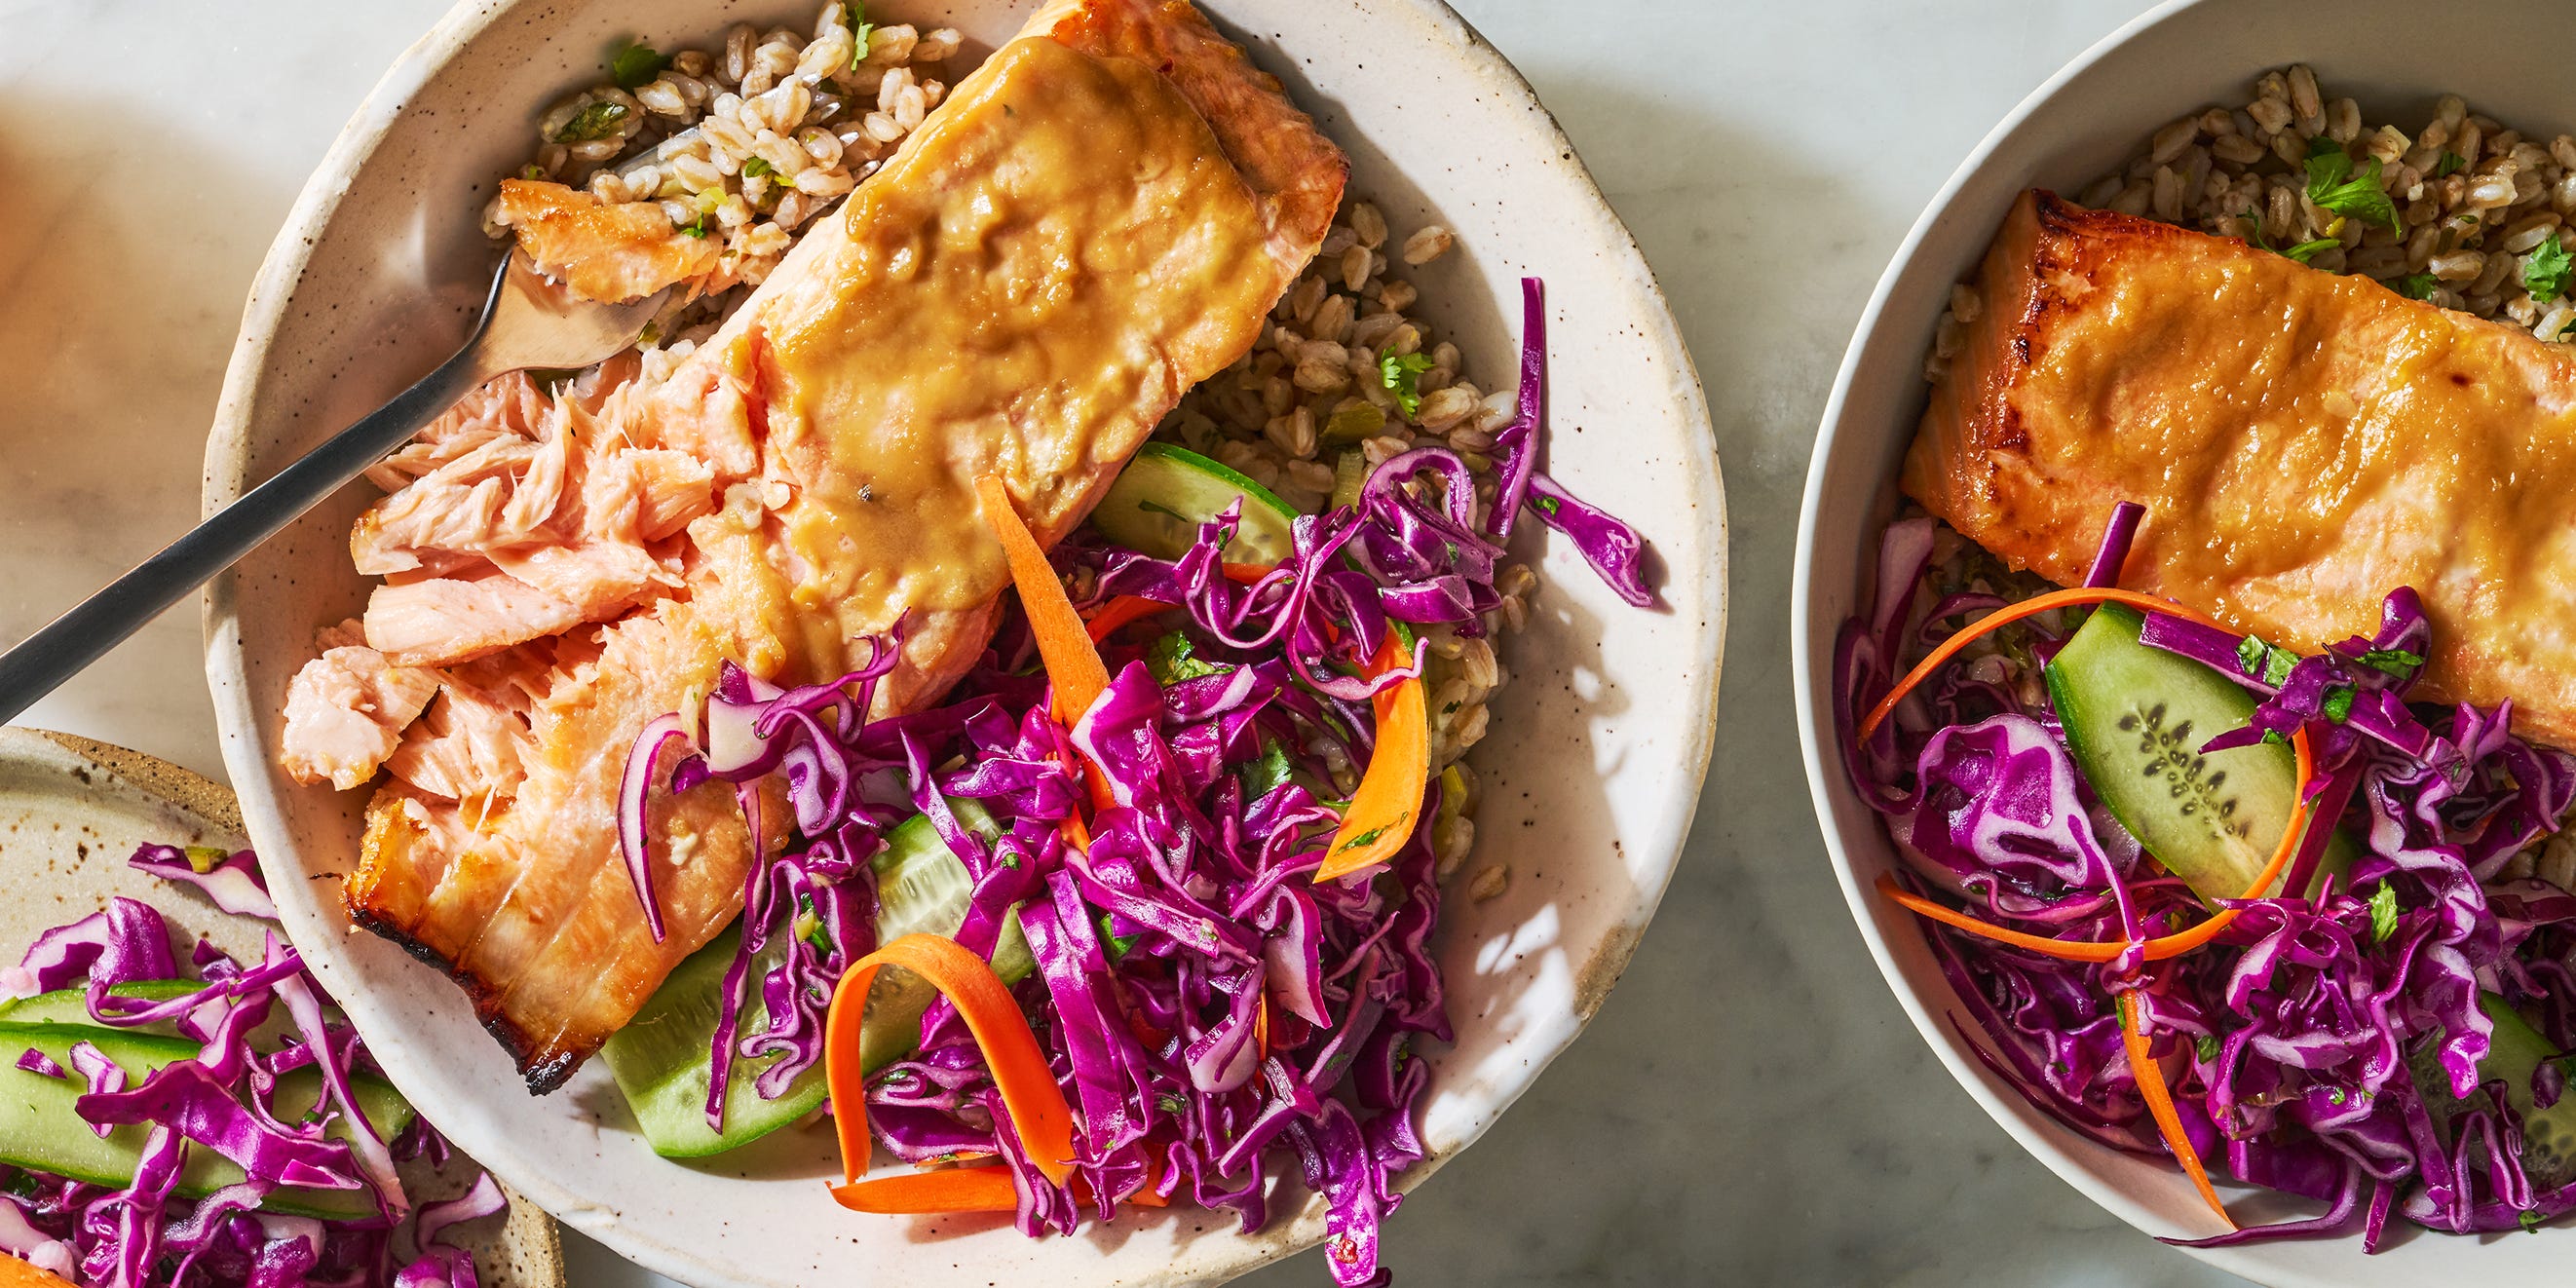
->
xmin=603 ymin=801 xmax=1036 ymax=1159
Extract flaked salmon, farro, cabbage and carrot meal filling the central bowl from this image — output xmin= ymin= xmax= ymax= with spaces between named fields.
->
xmin=284 ymin=0 xmax=1653 ymax=1283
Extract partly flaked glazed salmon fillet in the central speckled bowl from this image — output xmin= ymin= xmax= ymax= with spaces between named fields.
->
xmin=285 ymin=0 xmax=1347 ymax=1092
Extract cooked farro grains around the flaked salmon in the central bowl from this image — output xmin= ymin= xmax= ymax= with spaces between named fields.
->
xmin=484 ymin=3 xmax=1537 ymax=875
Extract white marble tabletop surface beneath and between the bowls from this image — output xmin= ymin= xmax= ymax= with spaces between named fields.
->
xmin=0 ymin=0 xmax=2233 ymax=1288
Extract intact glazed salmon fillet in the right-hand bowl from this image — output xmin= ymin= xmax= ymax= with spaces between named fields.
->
xmin=1904 ymin=193 xmax=2576 ymax=747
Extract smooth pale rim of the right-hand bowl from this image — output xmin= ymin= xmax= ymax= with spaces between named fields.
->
xmin=1791 ymin=0 xmax=2329 ymax=1275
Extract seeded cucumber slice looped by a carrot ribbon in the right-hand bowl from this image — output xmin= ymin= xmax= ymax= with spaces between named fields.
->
xmin=2048 ymin=603 xmax=2355 ymax=899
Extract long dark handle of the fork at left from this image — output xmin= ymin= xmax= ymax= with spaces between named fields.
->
xmin=0 ymin=329 xmax=500 ymax=721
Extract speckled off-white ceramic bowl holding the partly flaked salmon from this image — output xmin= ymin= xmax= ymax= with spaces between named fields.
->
xmin=207 ymin=0 xmax=1725 ymax=1288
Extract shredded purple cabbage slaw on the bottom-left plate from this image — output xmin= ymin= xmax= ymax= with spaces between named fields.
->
xmin=0 ymin=845 xmax=508 ymax=1288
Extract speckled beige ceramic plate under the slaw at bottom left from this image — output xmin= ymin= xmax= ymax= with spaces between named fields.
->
xmin=0 ymin=724 xmax=564 ymax=1288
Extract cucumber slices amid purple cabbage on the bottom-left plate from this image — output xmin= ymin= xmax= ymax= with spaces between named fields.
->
xmin=0 ymin=1023 xmax=412 ymax=1216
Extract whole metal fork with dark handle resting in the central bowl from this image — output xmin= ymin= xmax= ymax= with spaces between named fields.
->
xmin=0 ymin=252 xmax=669 ymax=721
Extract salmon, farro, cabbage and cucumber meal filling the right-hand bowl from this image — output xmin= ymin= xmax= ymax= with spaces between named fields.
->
xmin=1835 ymin=67 xmax=2576 ymax=1252
